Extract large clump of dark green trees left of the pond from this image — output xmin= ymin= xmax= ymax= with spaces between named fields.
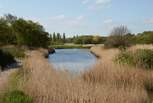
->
xmin=0 ymin=14 xmax=49 ymax=47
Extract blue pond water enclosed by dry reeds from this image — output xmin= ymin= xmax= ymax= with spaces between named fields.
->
xmin=49 ymin=49 xmax=96 ymax=73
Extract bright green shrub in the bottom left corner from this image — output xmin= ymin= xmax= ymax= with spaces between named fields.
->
xmin=3 ymin=90 xmax=33 ymax=103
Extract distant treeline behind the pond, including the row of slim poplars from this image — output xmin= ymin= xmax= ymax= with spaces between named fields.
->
xmin=50 ymin=32 xmax=106 ymax=45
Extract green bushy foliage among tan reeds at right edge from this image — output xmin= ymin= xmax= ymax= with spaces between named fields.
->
xmin=115 ymin=49 xmax=153 ymax=69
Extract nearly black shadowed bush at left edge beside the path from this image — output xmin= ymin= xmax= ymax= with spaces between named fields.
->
xmin=0 ymin=49 xmax=16 ymax=70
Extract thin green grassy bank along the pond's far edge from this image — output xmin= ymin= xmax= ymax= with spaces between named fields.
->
xmin=50 ymin=45 xmax=91 ymax=49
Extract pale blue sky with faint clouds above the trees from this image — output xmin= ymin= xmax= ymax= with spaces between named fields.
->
xmin=0 ymin=0 xmax=153 ymax=36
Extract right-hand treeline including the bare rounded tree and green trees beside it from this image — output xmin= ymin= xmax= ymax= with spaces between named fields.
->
xmin=104 ymin=25 xmax=153 ymax=48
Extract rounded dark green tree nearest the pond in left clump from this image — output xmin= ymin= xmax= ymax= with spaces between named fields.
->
xmin=13 ymin=18 xmax=49 ymax=47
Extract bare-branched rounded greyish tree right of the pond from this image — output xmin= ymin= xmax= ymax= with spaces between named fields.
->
xmin=105 ymin=25 xmax=130 ymax=48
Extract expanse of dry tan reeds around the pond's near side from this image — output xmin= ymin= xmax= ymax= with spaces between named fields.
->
xmin=9 ymin=47 xmax=153 ymax=103
